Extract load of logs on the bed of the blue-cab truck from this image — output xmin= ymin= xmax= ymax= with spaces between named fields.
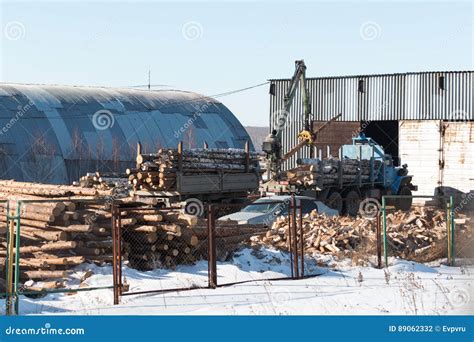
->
xmin=287 ymin=158 xmax=380 ymax=186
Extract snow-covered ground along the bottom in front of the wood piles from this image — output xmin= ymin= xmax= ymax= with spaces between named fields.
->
xmin=1 ymin=249 xmax=474 ymax=315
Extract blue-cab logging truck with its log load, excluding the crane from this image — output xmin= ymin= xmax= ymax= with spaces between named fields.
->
xmin=261 ymin=133 xmax=417 ymax=216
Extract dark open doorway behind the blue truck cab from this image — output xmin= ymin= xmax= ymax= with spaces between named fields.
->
xmin=361 ymin=120 xmax=400 ymax=166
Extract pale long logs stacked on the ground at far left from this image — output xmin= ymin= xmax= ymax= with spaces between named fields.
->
xmin=0 ymin=182 xmax=112 ymax=287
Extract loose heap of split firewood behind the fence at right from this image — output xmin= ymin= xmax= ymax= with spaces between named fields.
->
xmin=251 ymin=207 xmax=465 ymax=262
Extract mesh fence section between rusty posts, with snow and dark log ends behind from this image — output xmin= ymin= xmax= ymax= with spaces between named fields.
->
xmin=112 ymin=203 xmax=208 ymax=304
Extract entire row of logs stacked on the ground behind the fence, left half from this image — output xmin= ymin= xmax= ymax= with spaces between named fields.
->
xmin=0 ymin=181 xmax=266 ymax=292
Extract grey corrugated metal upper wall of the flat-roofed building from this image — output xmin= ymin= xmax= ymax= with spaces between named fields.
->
xmin=270 ymin=71 xmax=474 ymax=169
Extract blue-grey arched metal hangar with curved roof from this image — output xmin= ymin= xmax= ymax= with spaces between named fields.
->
xmin=0 ymin=84 xmax=250 ymax=184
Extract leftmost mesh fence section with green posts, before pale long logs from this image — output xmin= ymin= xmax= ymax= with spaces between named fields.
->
xmin=0 ymin=199 xmax=113 ymax=315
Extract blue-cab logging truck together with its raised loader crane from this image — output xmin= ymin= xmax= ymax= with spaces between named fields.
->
xmin=260 ymin=60 xmax=417 ymax=216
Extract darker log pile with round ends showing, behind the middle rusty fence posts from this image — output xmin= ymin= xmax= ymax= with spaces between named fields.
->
xmin=121 ymin=208 xmax=268 ymax=270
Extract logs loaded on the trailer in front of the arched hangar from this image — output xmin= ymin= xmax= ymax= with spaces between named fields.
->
xmin=126 ymin=148 xmax=259 ymax=191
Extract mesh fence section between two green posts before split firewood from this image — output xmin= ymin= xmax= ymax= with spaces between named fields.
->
xmin=377 ymin=195 xmax=457 ymax=266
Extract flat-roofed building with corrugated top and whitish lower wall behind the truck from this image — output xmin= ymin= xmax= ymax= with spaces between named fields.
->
xmin=270 ymin=71 xmax=474 ymax=202
